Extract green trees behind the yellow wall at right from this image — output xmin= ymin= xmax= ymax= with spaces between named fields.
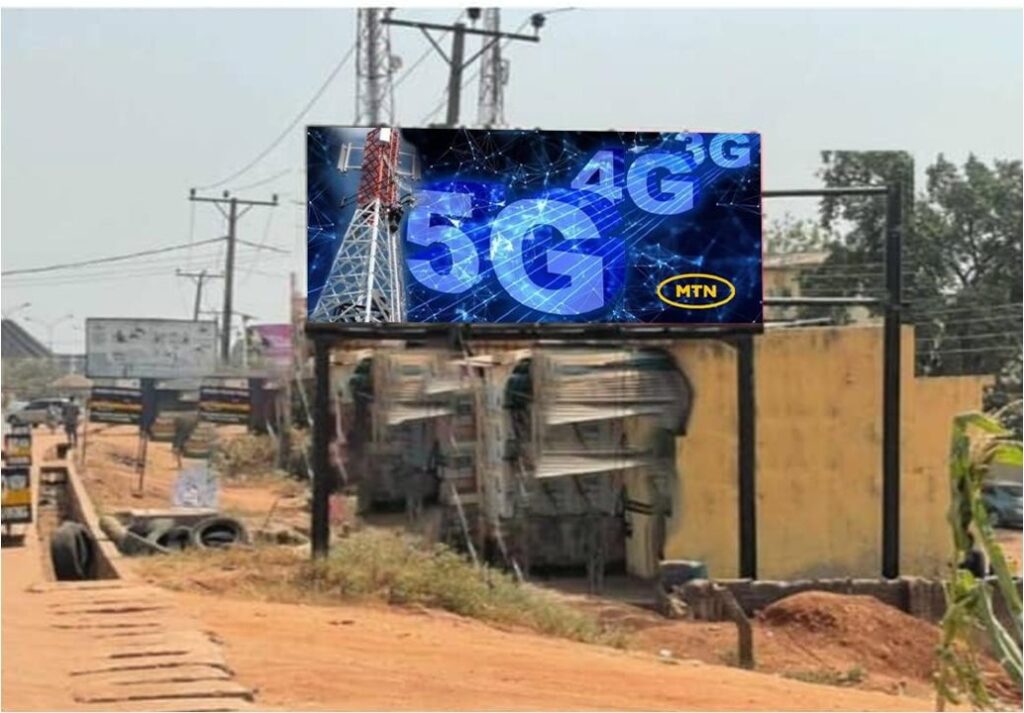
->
xmin=801 ymin=152 xmax=1022 ymax=432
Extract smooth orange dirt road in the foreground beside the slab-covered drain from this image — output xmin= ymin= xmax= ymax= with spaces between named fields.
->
xmin=174 ymin=593 xmax=932 ymax=711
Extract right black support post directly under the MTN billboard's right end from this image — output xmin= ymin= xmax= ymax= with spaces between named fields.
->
xmin=736 ymin=335 xmax=758 ymax=579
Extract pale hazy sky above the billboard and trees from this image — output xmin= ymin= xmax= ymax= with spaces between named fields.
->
xmin=0 ymin=8 xmax=1024 ymax=352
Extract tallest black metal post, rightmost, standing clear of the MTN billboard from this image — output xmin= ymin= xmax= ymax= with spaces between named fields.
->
xmin=882 ymin=183 xmax=903 ymax=579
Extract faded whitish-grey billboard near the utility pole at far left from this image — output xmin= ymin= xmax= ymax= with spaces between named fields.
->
xmin=85 ymin=319 xmax=217 ymax=379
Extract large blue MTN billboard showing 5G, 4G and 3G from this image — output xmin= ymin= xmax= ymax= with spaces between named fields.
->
xmin=306 ymin=127 xmax=763 ymax=326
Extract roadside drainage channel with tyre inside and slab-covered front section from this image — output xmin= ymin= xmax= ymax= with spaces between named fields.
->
xmin=29 ymin=448 xmax=256 ymax=711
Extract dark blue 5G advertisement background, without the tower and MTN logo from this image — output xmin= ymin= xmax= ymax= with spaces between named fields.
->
xmin=307 ymin=127 xmax=762 ymax=325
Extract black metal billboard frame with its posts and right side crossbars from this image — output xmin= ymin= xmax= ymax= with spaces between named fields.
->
xmin=305 ymin=182 xmax=912 ymax=579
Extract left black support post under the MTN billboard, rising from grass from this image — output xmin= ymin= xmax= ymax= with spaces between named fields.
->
xmin=309 ymin=338 xmax=331 ymax=558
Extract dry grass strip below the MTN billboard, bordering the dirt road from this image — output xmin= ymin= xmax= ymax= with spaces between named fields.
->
xmin=139 ymin=529 xmax=626 ymax=646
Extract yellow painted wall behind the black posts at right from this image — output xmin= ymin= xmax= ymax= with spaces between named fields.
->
xmin=666 ymin=327 xmax=987 ymax=579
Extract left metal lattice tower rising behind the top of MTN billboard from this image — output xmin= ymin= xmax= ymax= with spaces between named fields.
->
xmin=355 ymin=7 xmax=400 ymax=126
